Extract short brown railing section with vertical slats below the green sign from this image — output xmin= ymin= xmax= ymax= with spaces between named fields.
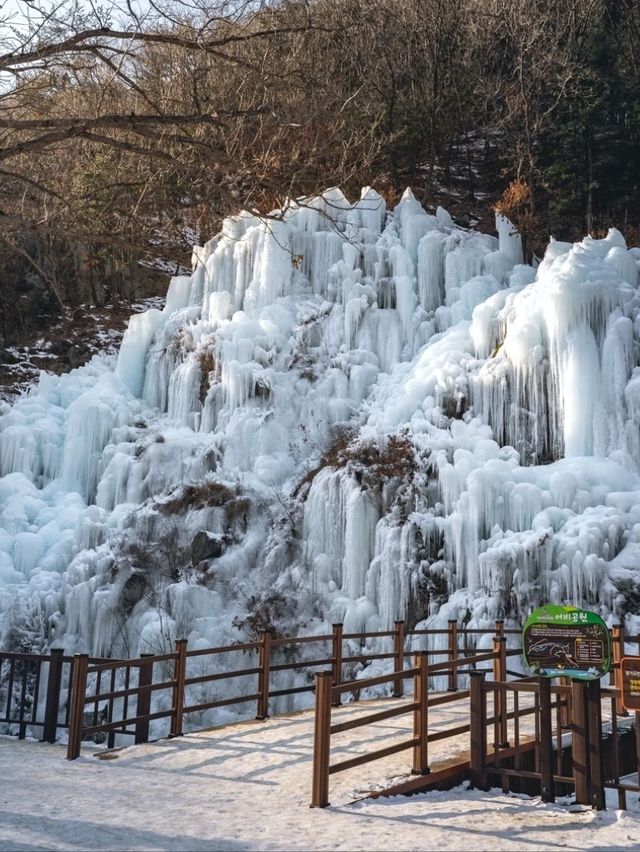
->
xmin=470 ymin=655 xmax=640 ymax=810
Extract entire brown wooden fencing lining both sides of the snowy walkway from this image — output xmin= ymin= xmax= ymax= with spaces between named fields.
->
xmin=6 ymin=621 xmax=640 ymax=807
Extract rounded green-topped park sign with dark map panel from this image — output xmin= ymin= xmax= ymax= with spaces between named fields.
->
xmin=522 ymin=604 xmax=611 ymax=680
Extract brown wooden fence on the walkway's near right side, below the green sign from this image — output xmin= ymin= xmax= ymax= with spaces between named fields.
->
xmin=311 ymin=623 xmax=640 ymax=808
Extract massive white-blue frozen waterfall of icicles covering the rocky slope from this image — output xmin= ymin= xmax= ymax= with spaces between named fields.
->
xmin=0 ymin=189 xmax=640 ymax=680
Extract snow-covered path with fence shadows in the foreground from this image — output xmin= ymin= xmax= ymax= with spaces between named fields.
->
xmin=0 ymin=702 xmax=640 ymax=850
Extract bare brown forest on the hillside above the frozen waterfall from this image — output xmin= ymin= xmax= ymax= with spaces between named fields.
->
xmin=0 ymin=0 xmax=640 ymax=345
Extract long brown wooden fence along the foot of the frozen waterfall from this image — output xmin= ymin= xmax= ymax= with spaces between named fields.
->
xmin=0 ymin=621 xmax=518 ymax=757
